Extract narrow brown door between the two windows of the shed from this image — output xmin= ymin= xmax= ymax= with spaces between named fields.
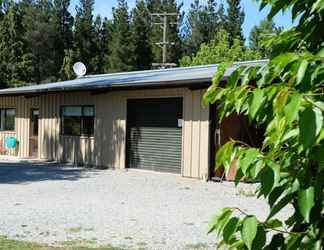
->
xmin=29 ymin=109 xmax=39 ymax=158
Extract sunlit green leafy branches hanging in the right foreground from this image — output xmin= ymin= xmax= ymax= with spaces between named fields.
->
xmin=204 ymin=0 xmax=324 ymax=249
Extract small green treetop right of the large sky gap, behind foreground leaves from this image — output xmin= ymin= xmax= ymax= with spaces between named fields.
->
xmin=249 ymin=19 xmax=282 ymax=58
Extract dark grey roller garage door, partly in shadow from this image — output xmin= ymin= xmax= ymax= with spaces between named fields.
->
xmin=127 ymin=98 xmax=182 ymax=173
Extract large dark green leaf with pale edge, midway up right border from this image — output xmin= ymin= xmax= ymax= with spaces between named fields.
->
xmin=299 ymin=108 xmax=323 ymax=149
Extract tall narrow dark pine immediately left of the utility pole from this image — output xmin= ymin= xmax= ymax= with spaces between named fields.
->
xmin=132 ymin=0 xmax=153 ymax=70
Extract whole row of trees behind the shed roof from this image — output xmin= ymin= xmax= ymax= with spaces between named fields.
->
xmin=0 ymin=0 xmax=274 ymax=87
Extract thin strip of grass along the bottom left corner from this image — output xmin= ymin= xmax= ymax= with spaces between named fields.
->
xmin=0 ymin=236 xmax=122 ymax=250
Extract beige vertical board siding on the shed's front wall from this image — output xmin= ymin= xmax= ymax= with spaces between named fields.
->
xmin=0 ymin=88 xmax=209 ymax=179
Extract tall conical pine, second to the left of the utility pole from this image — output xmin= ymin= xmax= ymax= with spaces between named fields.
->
xmin=107 ymin=0 xmax=134 ymax=72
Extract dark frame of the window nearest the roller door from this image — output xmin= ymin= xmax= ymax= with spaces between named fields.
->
xmin=60 ymin=105 xmax=96 ymax=138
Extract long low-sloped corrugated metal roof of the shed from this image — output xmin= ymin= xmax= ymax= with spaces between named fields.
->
xmin=0 ymin=60 xmax=267 ymax=95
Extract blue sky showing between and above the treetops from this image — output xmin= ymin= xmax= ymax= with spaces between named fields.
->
xmin=71 ymin=0 xmax=292 ymax=37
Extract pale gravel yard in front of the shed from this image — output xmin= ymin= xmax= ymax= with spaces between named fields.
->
xmin=0 ymin=162 xmax=284 ymax=249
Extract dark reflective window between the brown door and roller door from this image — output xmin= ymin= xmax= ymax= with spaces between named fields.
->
xmin=61 ymin=106 xmax=95 ymax=136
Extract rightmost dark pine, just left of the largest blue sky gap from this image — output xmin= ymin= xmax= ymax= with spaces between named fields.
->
xmin=226 ymin=0 xmax=245 ymax=44
